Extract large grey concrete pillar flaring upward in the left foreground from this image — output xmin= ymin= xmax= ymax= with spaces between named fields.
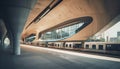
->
xmin=0 ymin=0 xmax=36 ymax=55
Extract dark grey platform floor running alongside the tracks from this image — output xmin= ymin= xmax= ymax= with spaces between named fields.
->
xmin=0 ymin=45 xmax=120 ymax=69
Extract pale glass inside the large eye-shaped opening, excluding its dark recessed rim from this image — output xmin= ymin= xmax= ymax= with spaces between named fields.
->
xmin=41 ymin=23 xmax=84 ymax=41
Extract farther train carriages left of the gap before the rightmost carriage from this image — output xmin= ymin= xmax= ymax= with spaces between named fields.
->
xmin=24 ymin=41 xmax=84 ymax=49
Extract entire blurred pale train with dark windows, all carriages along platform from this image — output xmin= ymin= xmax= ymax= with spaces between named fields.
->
xmin=22 ymin=41 xmax=120 ymax=51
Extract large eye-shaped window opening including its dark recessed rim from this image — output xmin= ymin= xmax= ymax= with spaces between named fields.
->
xmin=40 ymin=16 xmax=93 ymax=41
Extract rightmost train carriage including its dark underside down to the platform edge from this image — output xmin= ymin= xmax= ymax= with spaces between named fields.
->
xmin=84 ymin=42 xmax=120 ymax=56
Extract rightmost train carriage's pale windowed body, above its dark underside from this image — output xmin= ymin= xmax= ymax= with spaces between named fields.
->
xmin=84 ymin=42 xmax=120 ymax=51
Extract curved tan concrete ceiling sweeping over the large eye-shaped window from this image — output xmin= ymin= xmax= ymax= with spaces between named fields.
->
xmin=22 ymin=0 xmax=120 ymax=40
